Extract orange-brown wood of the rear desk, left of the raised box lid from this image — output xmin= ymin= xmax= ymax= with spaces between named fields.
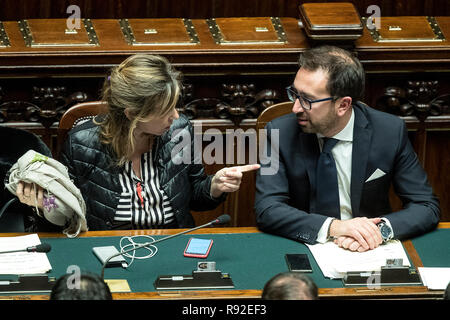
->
xmin=0 ymin=18 xmax=307 ymax=61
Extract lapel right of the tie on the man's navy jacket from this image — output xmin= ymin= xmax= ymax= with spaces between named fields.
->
xmin=350 ymin=106 xmax=372 ymax=217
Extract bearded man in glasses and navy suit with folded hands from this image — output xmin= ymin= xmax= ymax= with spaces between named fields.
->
xmin=255 ymin=46 xmax=440 ymax=252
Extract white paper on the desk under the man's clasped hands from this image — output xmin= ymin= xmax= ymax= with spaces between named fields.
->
xmin=307 ymin=240 xmax=411 ymax=279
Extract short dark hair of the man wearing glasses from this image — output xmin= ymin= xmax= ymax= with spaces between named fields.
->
xmin=298 ymin=45 xmax=365 ymax=101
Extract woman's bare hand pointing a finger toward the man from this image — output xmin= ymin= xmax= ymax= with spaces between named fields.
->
xmin=211 ymin=164 xmax=261 ymax=198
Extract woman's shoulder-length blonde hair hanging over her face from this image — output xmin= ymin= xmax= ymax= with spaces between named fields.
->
xmin=97 ymin=54 xmax=181 ymax=166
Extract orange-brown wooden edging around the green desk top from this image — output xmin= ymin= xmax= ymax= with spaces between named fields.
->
xmin=1 ymin=223 xmax=450 ymax=300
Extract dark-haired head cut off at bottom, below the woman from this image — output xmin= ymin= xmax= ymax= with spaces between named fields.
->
xmin=50 ymin=273 xmax=112 ymax=300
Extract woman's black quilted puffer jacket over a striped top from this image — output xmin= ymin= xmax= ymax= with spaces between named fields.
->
xmin=60 ymin=115 xmax=226 ymax=230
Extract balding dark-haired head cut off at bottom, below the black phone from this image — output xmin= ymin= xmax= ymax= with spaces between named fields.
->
xmin=261 ymin=272 xmax=318 ymax=300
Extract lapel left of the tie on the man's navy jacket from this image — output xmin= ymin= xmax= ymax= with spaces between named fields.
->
xmin=299 ymin=132 xmax=320 ymax=212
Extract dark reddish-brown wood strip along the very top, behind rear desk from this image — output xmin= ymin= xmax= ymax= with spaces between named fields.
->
xmin=0 ymin=0 xmax=450 ymax=20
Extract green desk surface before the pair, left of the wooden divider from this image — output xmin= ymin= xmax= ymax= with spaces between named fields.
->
xmin=41 ymin=233 xmax=342 ymax=292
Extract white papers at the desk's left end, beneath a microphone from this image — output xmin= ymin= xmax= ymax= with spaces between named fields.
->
xmin=0 ymin=233 xmax=52 ymax=274
